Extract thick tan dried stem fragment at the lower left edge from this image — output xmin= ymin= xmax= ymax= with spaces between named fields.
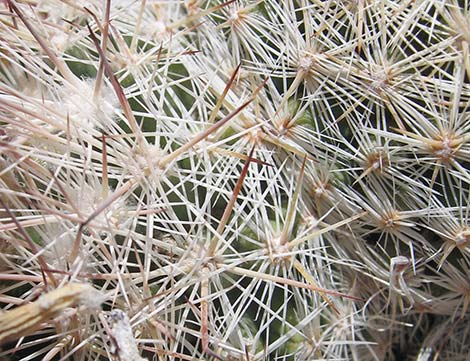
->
xmin=0 ymin=283 xmax=97 ymax=344
